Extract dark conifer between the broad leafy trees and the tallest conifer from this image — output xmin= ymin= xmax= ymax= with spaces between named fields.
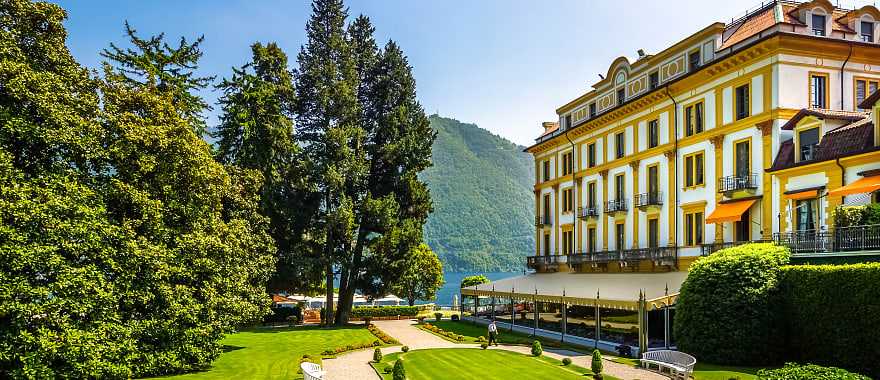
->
xmin=214 ymin=43 xmax=323 ymax=292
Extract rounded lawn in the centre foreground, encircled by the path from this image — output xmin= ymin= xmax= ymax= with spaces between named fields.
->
xmin=373 ymin=348 xmax=615 ymax=380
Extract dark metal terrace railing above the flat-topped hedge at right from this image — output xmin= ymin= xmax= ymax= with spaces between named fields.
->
xmin=773 ymin=225 xmax=880 ymax=253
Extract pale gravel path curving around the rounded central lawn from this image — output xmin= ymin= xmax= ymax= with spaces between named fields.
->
xmin=323 ymin=320 xmax=668 ymax=380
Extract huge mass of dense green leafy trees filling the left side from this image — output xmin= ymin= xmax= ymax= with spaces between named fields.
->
xmin=0 ymin=0 xmax=274 ymax=378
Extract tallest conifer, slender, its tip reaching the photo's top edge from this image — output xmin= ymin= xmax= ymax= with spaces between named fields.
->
xmin=296 ymin=0 xmax=366 ymax=323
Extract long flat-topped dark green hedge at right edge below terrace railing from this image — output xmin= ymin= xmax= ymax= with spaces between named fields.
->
xmin=781 ymin=263 xmax=880 ymax=378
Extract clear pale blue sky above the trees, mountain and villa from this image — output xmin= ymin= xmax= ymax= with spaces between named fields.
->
xmin=57 ymin=0 xmax=784 ymax=145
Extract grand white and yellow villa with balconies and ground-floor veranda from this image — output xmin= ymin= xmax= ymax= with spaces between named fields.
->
xmin=462 ymin=0 xmax=880 ymax=353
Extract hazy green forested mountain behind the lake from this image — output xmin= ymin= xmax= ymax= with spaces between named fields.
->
xmin=421 ymin=115 xmax=535 ymax=272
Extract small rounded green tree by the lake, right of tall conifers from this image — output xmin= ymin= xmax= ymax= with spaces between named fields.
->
xmin=391 ymin=244 xmax=443 ymax=306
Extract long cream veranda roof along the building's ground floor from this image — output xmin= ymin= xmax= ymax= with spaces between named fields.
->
xmin=461 ymin=272 xmax=687 ymax=310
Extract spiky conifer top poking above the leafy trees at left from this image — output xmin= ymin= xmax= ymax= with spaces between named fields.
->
xmin=101 ymin=21 xmax=214 ymax=137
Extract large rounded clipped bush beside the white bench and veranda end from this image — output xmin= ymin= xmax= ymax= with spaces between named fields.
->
xmin=675 ymin=243 xmax=789 ymax=366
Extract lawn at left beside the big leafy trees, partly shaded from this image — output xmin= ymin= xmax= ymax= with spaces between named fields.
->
xmin=156 ymin=327 xmax=376 ymax=379
